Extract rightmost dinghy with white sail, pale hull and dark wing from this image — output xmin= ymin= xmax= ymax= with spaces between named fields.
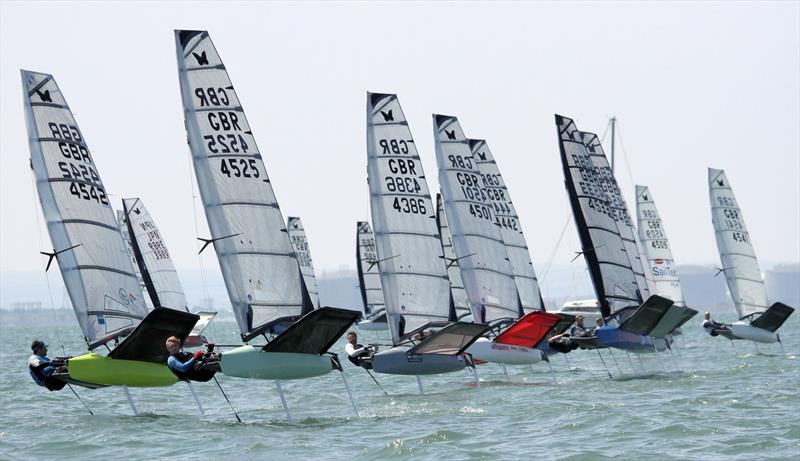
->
xmin=708 ymin=168 xmax=794 ymax=343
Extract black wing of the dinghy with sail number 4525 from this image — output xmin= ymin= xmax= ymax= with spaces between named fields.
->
xmin=263 ymin=307 xmax=361 ymax=355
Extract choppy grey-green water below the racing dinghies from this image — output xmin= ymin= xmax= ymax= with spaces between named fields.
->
xmin=0 ymin=315 xmax=800 ymax=460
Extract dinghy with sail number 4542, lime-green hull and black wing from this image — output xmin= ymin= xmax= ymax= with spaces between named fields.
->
xmin=22 ymin=70 xmax=198 ymax=388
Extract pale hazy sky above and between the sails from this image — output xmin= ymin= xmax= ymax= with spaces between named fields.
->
xmin=0 ymin=1 xmax=800 ymax=280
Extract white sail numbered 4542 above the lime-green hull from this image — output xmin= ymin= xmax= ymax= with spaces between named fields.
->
xmin=22 ymin=70 xmax=147 ymax=349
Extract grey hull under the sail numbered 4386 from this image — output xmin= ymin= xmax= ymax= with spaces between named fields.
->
xmin=372 ymin=348 xmax=466 ymax=375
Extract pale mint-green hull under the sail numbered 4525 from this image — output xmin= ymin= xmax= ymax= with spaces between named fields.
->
xmin=221 ymin=346 xmax=333 ymax=380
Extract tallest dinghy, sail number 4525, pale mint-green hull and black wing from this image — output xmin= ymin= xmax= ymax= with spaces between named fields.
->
xmin=175 ymin=30 xmax=359 ymax=380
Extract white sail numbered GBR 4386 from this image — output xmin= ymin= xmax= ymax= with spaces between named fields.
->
xmin=367 ymin=93 xmax=450 ymax=344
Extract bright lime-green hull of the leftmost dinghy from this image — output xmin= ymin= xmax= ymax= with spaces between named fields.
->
xmin=67 ymin=352 xmax=178 ymax=387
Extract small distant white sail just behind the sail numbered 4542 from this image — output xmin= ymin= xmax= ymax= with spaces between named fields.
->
xmin=122 ymin=198 xmax=189 ymax=312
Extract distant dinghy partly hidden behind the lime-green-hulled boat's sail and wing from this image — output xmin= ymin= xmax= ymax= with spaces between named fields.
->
xmin=122 ymin=197 xmax=217 ymax=348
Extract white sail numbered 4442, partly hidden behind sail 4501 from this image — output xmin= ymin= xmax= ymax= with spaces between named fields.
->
xmin=469 ymin=139 xmax=544 ymax=313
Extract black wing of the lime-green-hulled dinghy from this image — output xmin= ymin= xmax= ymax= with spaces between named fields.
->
xmin=108 ymin=307 xmax=200 ymax=364
